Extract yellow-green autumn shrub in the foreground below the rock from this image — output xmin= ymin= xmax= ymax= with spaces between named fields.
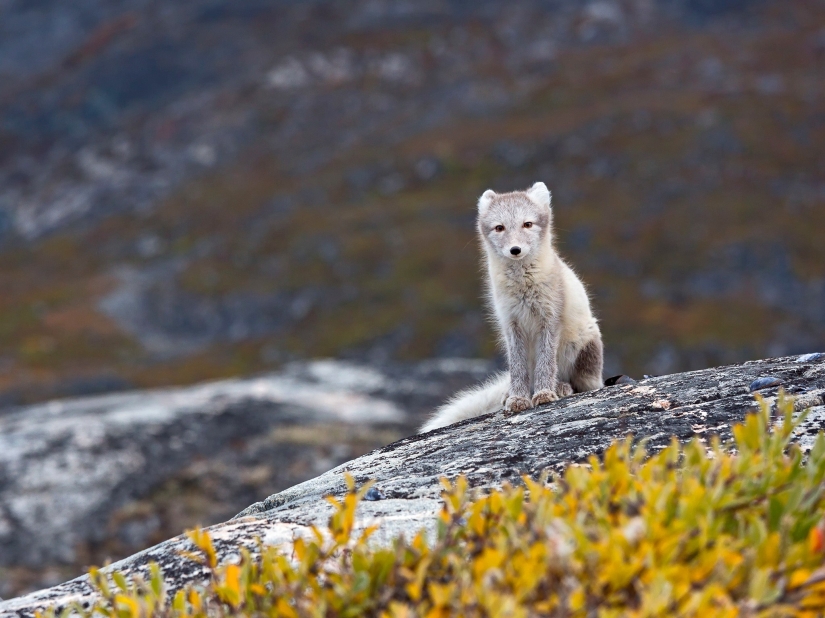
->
xmin=50 ymin=396 xmax=825 ymax=618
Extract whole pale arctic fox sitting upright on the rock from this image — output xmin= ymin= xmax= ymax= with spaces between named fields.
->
xmin=421 ymin=182 xmax=603 ymax=432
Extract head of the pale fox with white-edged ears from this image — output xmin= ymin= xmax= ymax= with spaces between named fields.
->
xmin=478 ymin=182 xmax=553 ymax=261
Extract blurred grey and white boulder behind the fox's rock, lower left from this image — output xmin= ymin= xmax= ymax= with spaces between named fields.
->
xmin=0 ymin=360 xmax=491 ymax=597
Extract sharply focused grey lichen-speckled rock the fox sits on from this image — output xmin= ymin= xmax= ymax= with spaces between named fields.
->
xmin=0 ymin=354 xmax=825 ymax=617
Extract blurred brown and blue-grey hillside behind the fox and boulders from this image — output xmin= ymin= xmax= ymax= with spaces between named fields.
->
xmin=0 ymin=0 xmax=825 ymax=405
